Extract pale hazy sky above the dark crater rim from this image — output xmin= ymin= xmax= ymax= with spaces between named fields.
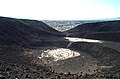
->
xmin=0 ymin=0 xmax=120 ymax=20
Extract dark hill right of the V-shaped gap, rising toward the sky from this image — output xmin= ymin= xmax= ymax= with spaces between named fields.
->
xmin=67 ymin=21 xmax=120 ymax=33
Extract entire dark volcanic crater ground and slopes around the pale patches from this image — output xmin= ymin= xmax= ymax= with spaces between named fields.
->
xmin=0 ymin=17 xmax=120 ymax=79
